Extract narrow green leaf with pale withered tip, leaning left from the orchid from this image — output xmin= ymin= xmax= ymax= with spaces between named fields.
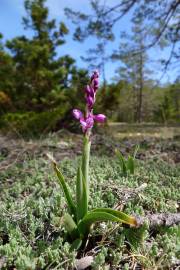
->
xmin=47 ymin=154 xmax=76 ymax=217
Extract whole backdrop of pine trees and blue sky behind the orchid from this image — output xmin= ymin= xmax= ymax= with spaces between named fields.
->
xmin=0 ymin=0 xmax=180 ymax=134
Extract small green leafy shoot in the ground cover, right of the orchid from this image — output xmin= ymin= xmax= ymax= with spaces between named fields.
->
xmin=115 ymin=145 xmax=139 ymax=176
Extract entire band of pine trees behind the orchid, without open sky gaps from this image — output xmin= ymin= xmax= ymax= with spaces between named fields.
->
xmin=0 ymin=0 xmax=180 ymax=134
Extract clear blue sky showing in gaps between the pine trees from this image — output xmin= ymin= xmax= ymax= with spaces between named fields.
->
xmin=0 ymin=0 xmax=177 ymax=83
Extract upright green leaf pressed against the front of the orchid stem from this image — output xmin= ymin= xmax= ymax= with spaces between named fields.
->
xmin=76 ymin=167 xmax=88 ymax=222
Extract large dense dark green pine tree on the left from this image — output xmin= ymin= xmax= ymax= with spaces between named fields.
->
xmin=0 ymin=0 xmax=83 ymax=116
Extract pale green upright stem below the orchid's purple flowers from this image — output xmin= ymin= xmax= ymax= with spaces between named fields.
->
xmin=82 ymin=134 xmax=91 ymax=204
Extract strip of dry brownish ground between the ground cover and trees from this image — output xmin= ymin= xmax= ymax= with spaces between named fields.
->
xmin=0 ymin=131 xmax=180 ymax=171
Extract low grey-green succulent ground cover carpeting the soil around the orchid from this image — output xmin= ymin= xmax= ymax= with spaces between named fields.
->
xmin=0 ymin=138 xmax=180 ymax=270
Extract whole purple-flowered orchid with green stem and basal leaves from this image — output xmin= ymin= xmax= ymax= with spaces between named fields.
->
xmin=49 ymin=71 xmax=137 ymax=249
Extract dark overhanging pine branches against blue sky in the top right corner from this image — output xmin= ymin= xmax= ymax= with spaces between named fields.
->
xmin=66 ymin=0 xmax=180 ymax=77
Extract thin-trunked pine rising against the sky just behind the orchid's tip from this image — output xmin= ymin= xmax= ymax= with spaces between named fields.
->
xmin=65 ymin=0 xmax=114 ymax=92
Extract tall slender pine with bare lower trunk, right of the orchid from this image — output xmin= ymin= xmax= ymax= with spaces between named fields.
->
xmin=112 ymin=17 xmax=150 ymax=123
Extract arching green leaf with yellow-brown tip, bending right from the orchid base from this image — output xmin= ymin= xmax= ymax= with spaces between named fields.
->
xmin=92 ymin=208 xmax=137 ymax=226
